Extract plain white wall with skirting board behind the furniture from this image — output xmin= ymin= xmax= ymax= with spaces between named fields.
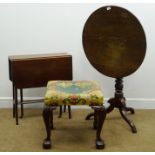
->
xmin=0 ymin=3 xmax=155 ymax=108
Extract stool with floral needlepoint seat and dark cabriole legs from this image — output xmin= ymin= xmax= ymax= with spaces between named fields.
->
xmin=43 ymin=81 xmax=106 ymax=149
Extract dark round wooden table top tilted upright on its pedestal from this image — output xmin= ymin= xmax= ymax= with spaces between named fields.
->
xmin=82 ymin=6 xmax=146 ymax=78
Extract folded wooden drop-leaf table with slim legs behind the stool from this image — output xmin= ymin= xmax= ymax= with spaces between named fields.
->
xmin=9 ymin=53 xmax=72 ymax=124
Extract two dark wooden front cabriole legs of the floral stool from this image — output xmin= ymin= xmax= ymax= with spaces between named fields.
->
xmin=43 ymin=106 xmax=106 ymax=149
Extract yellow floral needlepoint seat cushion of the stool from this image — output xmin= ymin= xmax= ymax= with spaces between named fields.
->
xmin=44 ymin=81 xmax=103 ymax=106
